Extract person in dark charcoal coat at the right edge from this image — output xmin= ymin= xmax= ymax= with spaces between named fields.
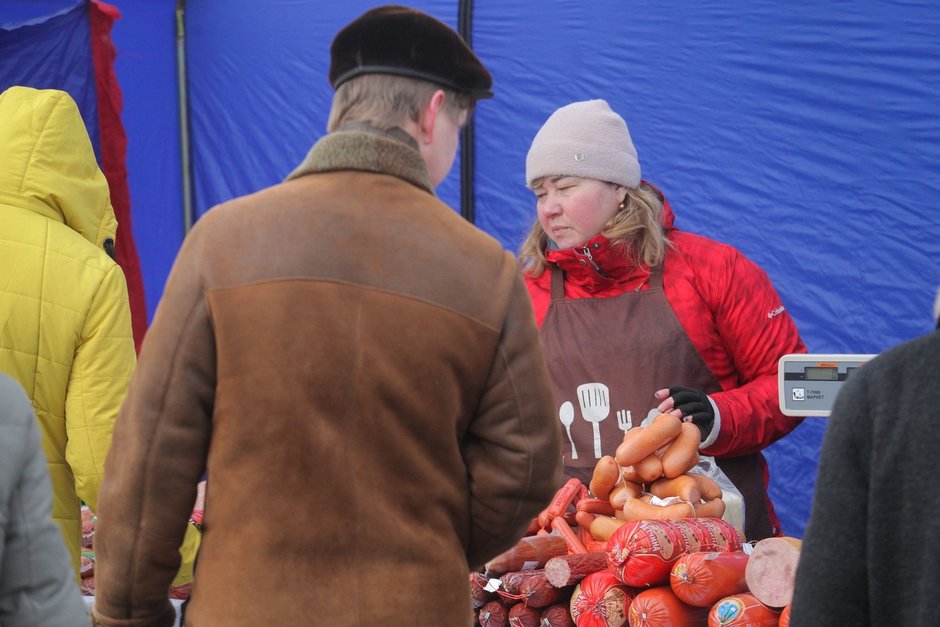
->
xmin=790 ymin=295 xmax=940 ymax=627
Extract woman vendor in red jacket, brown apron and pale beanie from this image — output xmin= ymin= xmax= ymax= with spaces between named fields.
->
xmin=520 ymin=100 xmax=806 ymax=540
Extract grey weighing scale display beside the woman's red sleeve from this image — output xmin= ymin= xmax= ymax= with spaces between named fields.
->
xmin=777 ymin=354 xmax=875 ymax=416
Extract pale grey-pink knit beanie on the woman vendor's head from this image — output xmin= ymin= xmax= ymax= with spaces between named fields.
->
xmin=525 ymin=100 xmax=640 ymax=188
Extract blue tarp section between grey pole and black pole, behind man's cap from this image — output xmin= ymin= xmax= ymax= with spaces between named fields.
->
xmin=186 ymin=0 xmax=459 ymax=215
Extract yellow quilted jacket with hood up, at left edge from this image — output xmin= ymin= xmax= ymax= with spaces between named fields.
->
xmin=0 ymin=87 xmax=194 ymax=588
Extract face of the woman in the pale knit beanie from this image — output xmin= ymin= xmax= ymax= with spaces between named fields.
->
xmin=532 ymin=176 xmax=626 ymax=248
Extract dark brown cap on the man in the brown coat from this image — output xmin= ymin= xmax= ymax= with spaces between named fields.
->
xmin=330 ymin=4 xmax=493 ymax=99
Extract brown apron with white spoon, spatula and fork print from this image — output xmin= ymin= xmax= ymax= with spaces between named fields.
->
xmin=542 ymin=266 xmax=774 ymax=540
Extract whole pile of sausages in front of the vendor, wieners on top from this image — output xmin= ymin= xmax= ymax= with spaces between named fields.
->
xmin=470 ymin=414 xmax=800 ymax=627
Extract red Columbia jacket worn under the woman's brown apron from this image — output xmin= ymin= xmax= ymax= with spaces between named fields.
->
xmin=526 ymin=194 xmax=806 ymax=464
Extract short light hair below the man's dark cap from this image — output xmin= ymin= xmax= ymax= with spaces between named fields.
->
xmin=327 ymin=74 xmax=473 ymax=132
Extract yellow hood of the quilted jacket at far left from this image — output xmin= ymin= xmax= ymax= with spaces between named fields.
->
xmin=0 ymin=87 xmax=117 ymax=248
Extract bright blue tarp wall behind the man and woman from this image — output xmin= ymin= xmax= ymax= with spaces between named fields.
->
xmin=0 ymin=0 xmax=940 ymax=536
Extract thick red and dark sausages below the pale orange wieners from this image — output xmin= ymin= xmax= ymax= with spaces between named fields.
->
xmin=470 ymin=518 xmax=799 ymax=627
